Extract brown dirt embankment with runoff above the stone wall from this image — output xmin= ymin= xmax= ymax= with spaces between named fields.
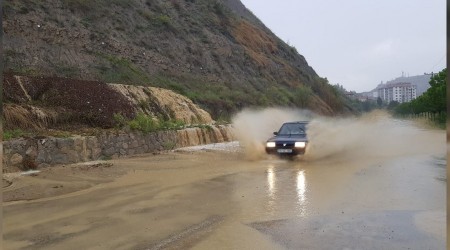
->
xmin=3 ymin=74 xmax=214 ymax=130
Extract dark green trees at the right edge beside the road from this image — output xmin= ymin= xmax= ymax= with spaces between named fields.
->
xmin=390 ymin=68 xmax=447 ymax=125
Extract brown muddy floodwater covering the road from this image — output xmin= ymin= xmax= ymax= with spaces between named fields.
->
xmin=3 ymin=114 xmax=446 ymax=249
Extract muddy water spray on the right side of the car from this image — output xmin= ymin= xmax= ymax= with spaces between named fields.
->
xmin=305 ymin=111 xmax=445 ymax=160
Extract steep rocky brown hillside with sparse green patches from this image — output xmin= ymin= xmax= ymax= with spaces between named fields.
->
xmin=3 ymin=0 xmax=349 ymax=119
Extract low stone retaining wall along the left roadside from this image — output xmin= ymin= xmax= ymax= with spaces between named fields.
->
xmin=3 ymin=125 xmax=234 ymax=172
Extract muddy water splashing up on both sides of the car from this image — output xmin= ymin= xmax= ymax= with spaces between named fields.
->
xmin=233 ymin=108 xmax=446 ymax=161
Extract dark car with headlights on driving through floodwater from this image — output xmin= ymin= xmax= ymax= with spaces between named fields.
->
xmin=266 ymin=121 xmax=308 ymax=156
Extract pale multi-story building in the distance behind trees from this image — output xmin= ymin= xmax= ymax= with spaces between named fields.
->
xmin=377 ymin=82 xmax=417 ymax=103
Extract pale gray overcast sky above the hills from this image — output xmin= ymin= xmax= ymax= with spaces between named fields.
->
xmin=241 ymin=0 xmax=447 ymax=92
